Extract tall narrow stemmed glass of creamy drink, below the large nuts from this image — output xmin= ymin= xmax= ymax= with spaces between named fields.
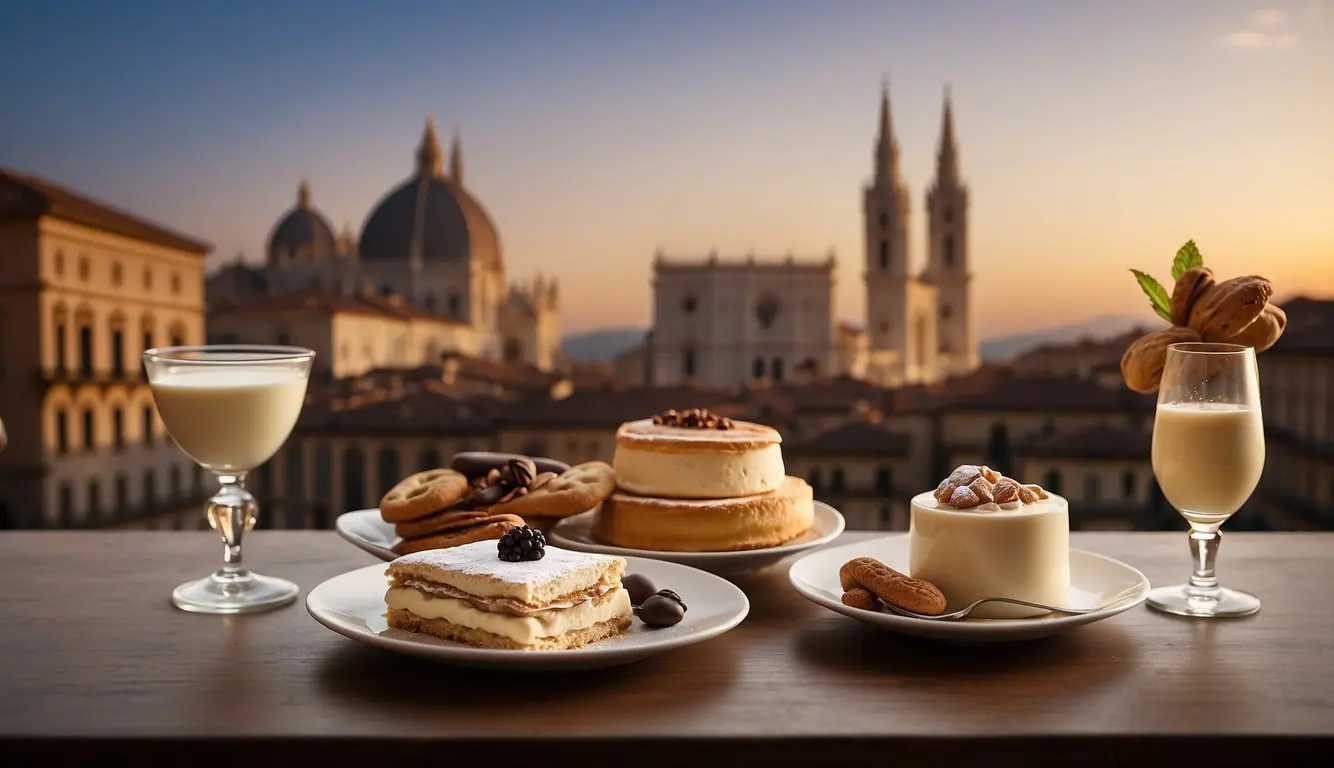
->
xmin=1149 ymin=343 xmax=1265 ymax=617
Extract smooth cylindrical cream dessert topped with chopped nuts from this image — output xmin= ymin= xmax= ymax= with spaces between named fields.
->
xmin=908 ymin=465 xmax=1070 ymax=619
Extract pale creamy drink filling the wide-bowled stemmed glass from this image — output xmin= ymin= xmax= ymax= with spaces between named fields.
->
xmin=151 ymin=367 xmax=307 ymax=473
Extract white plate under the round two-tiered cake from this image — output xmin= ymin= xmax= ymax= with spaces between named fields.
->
xmin=547 ymin=501 xmax=844 ymax=576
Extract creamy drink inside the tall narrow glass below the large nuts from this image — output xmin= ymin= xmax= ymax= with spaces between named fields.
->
xmin=1153 ymin=403 xmax=1265 ymax=527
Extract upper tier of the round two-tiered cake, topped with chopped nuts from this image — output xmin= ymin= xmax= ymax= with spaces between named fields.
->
xmin=612 ymin=411 xmax=786 ymax=499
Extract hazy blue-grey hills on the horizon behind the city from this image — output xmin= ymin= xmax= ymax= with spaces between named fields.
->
xmin=562 ymin=315 xmax=1154 ymax=363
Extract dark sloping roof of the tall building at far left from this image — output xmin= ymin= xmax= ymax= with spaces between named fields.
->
xmin=0 ymin=168 xmax=213 ymax=255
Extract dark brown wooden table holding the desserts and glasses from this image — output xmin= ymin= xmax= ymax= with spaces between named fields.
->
xmin=0 ymin=532 xmax=1334 ymax=768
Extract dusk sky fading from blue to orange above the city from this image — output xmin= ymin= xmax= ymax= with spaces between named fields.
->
xmin=0 ymin=0 xmax=1334 ymax=337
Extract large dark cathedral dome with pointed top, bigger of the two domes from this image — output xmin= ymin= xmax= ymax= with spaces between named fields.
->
xmin=358 ymin=121 xmax=500 ymax=268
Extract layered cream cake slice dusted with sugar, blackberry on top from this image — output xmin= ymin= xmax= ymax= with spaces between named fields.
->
xmin=384 ymin=528 xmax=632 ymax=651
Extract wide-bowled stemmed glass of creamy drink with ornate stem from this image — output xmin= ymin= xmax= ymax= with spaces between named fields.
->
xmin=144 ymin=345 xmax=315 ymax=613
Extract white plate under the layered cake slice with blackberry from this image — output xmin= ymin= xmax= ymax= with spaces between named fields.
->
xmin=305 ymin=557 xmax=750 ymax=669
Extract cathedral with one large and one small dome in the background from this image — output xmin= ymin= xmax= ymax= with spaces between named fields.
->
xmin=208 ymin=119 xmax=560 ymax=369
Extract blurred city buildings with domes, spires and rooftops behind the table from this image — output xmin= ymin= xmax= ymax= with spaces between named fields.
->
xmin=0 ymin=82 xmax=1334 ymax=531
